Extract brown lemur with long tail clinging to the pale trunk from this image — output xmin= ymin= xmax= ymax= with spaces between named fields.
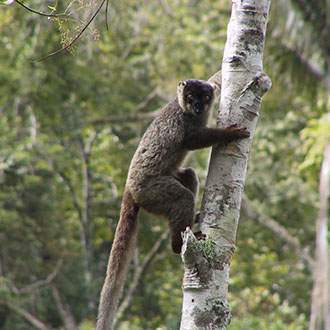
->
xmin=96 ymin=72 xmax=250 ymax=330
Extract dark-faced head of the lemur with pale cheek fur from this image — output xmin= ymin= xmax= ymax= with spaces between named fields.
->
xmin=177 ymin=79 xmax=214 ymax=116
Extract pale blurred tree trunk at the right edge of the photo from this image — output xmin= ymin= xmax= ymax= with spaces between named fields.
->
xmin=309 ymin=145 xmax=330 ymax=330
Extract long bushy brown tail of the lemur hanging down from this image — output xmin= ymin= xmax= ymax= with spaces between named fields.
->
xmin=96 ymin=189 xmax=139 ymax=330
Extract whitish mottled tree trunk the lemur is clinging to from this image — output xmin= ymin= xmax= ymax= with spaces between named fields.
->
xmin=180 ymin=0 xmax=271 ymax=330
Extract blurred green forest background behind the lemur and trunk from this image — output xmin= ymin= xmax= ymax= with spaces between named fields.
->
xmin=0 ymin=0 xmax=330 ymax=330
